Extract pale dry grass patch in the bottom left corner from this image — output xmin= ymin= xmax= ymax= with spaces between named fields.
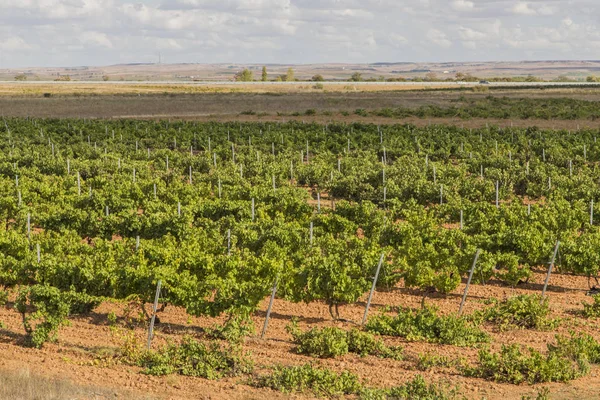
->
xmin=0 ymin=369 xmax=157 ymax=400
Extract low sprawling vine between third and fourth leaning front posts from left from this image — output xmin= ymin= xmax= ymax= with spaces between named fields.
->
xmin=365 ymin=306 xmax=489 ymax=346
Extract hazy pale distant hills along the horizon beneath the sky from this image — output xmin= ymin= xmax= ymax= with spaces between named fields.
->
xmin=5 ymin=60 xmax=600 ymax=82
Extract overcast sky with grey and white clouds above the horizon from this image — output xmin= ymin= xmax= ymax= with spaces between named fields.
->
xmin=0 ymin=0 xmax=600 ymax=68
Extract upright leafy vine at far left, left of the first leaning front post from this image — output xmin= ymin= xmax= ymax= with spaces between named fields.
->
xmin=15 ymin=285 xmax=70 ymax=348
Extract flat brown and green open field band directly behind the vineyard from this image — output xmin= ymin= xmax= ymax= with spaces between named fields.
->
xmin=0 ymin=84 xmax=600 ymax=130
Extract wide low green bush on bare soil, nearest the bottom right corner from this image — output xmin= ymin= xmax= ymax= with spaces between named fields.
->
xmin=463 ymin=344 xmax=587 ymax=384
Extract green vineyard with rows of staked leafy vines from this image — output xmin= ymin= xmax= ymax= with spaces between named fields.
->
xmin=0 ymin=118 xmax=600 ymax=399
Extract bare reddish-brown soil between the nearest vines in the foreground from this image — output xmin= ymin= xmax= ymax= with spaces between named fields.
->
xmin=0 ymin=271 xmax=600 ymax=400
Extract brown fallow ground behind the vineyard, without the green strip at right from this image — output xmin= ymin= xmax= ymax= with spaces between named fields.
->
xmin=0 ymin=84 xmax=600 ymax=129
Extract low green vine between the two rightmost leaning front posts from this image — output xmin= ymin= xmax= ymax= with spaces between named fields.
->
xmin=481 ymin=294 xmax=560 ymax=330
